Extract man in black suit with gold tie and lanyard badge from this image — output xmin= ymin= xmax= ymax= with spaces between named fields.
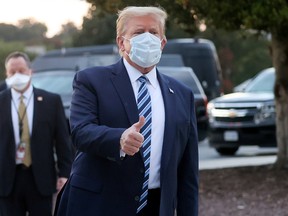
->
xmin=0 ymin=51 xmax=73 ymax=216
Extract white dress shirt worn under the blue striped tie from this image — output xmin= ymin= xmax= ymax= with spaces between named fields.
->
xmin=123 ymin=59 xmax=165 ymax=189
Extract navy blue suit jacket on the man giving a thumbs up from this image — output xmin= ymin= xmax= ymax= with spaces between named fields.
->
xmin=57 ymin=60 xmax=198 ymax=216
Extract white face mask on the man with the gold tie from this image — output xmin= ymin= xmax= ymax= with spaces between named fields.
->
xmin=6 ymin=73 xmax=31 ymax=91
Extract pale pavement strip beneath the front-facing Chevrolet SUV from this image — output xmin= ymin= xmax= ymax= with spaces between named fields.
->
xmin=199 ymin=140 xmax=277 ymax=169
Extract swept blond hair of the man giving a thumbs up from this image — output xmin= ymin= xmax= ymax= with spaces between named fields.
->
xmin=116 ymin=6 xmax=167 ymax=36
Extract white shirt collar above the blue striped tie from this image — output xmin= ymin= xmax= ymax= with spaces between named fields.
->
xmin=123 ymin=58 xmax=157 ymax=88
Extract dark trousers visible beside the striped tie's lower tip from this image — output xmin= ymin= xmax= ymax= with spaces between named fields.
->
xmin=137 ymin=188 xmax=160 ymax=216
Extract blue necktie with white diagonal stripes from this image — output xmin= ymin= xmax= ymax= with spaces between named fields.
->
xmin=137 ymin=76 xmax=152 ymax=213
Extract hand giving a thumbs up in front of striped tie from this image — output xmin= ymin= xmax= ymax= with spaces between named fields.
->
xmin=120 ymin=116 xmax=145 ymax=156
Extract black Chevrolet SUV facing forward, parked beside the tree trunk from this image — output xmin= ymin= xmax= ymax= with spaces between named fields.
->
xmin=207 ymin=68 xmax=276 ymax=155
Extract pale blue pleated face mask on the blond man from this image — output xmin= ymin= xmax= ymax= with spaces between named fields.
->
xmin=124 ymin=32 xmax=162 ymax=68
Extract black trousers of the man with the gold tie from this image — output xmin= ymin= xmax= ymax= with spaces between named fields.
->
xmin=0 ymin=165 xmax=52 ymax=216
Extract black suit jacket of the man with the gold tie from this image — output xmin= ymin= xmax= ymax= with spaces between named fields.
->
xmin=0 ymin=88 xmax=73 ymax=197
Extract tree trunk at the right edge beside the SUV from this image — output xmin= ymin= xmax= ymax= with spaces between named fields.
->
xmin=272 ymin=34 xmax=288 ymax=168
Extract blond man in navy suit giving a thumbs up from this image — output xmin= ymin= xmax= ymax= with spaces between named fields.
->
xmin=55 ymin=6 xmax=198 ymax=216
